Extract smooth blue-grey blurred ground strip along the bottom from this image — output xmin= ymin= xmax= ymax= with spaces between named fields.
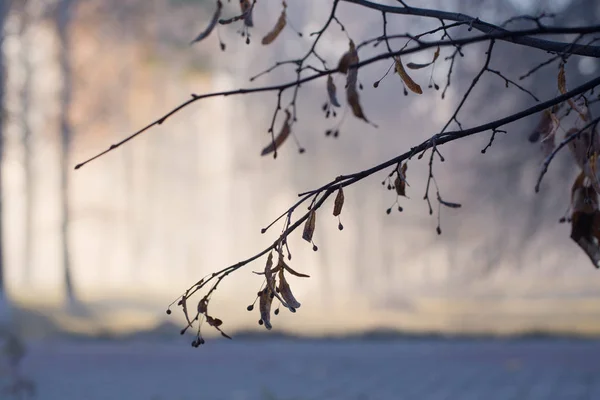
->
xmin=16 ymin=340 xmax=600 ymax=400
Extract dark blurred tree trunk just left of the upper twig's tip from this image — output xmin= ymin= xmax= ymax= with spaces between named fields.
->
xmin=56 ymin=0 xmax=77 ymax=304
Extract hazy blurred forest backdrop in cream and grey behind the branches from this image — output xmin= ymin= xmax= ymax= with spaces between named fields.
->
xmin=0 ymin=0 xmax=600 ymax=335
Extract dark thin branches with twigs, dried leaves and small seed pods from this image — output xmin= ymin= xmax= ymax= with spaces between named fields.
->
xmin=75 ymin=0 xmax=600 ymax=347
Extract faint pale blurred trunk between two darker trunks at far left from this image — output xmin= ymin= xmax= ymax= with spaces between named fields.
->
xmin=19 ymin=6 xmax=35 ymax=285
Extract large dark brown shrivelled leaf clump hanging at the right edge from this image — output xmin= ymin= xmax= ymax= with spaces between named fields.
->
xmin=571 ymin=172 xmax=600 ymax=268
